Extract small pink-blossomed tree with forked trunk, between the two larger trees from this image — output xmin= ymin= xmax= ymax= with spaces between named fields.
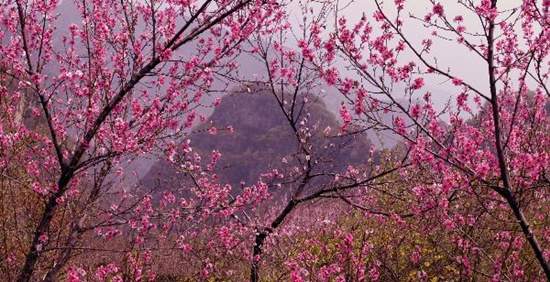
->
xmin=127 ymin=4 xmax=410 ymax=281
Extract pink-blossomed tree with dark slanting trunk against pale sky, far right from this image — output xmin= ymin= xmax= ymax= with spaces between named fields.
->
xmin=300 ymin=0 xmax=550 ymax=280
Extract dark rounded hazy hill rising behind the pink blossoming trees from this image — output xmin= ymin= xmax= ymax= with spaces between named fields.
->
xmin=142 ymin=85 xmax=376 ymax=194
